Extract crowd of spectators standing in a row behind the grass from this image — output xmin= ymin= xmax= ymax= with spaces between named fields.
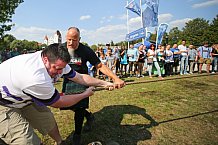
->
xmin=89 ymin=40 xmax=218 ymax=81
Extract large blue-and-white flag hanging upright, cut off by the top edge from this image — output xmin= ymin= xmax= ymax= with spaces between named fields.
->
xmin=141 ymin=0 xmax=159 ymax=28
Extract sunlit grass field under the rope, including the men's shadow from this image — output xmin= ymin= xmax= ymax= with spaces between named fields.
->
xmin=42 ymin=75 xmax=218 ymax=145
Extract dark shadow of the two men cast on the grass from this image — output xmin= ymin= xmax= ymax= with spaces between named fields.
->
xmin=63 ymin=105 xmax=158 ymax=145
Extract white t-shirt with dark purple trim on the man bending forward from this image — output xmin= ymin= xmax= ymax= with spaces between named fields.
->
xmin=0 ymin=51 xmax=76 ymax=108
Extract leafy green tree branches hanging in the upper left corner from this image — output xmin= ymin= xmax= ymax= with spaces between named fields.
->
xmin=0 ymin=0 xmax=23 ymax=39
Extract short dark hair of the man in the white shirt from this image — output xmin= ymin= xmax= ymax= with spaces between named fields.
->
xmin=42 ymin=43 xmax=71 ymax=63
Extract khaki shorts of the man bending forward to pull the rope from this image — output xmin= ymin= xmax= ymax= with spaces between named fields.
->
xmin=0 ymin=103 xmax=56 ymax=145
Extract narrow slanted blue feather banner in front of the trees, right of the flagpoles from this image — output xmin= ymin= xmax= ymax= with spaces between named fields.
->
xmin=156 ymin=23 xmax=168 ymax=48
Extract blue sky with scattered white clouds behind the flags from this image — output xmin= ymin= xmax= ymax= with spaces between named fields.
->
xmin=7 ymin=0 xmax=218 ymax=45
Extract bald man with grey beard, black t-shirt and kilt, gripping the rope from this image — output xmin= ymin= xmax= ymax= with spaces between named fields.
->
xmin=62 ymin=27 xmax=125 ymax=145
